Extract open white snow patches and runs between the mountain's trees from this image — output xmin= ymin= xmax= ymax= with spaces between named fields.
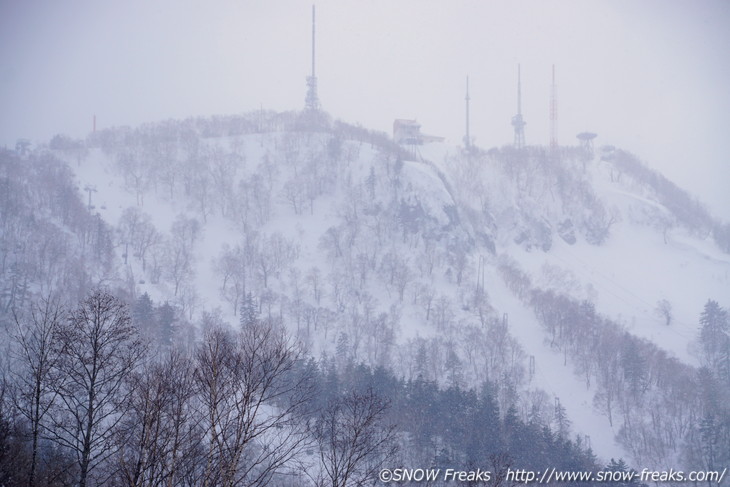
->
xmin=59 ymin=126 xmax=730 ymax=466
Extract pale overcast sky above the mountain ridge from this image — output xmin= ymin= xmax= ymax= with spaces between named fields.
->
xmin=0 ymin=0 xmax=730 ymax=220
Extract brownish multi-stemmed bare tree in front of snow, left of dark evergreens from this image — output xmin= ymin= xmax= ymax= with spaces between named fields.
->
xmin=196 ymin=322 xmax=311 ymax=487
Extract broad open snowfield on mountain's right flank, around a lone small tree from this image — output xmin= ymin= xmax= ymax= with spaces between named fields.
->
xmin=511 ymin=160 xmax=730 ymax=365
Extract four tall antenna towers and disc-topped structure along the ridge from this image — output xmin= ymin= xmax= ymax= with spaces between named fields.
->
xmin=304 ymin=5 xmax=564 ymax=150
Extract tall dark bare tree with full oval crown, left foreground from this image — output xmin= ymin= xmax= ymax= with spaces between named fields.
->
xmin=47 ymin=290 xmax=145 ymax=487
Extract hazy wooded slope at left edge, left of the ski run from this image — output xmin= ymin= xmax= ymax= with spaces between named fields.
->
xmin=0 ymin=150 xmax=114 ymax=312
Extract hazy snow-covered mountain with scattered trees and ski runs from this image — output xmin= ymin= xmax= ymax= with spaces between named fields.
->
xmin=2 ymin=112 xmax=730 ymax=467
